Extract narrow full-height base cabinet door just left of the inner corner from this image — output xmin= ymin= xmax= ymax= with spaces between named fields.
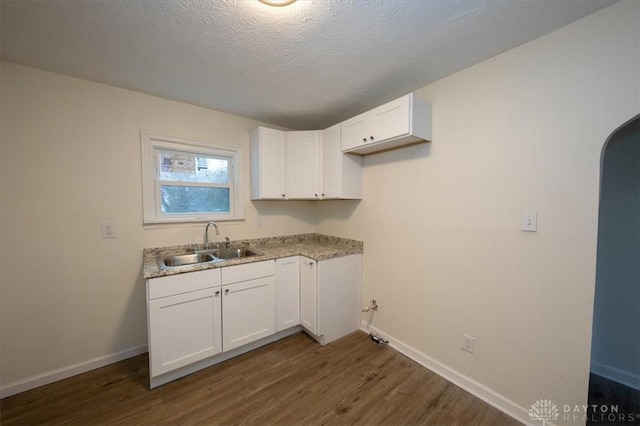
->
xmin=276 ymin=256 xmax=300 ymax=331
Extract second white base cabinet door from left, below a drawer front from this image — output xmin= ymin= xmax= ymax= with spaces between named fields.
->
xmin=222 ymin=276 xmax=276 ymax=351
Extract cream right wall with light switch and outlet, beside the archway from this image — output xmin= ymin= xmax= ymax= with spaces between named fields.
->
xmin=316 ymin=1 xmax=640 ymax=422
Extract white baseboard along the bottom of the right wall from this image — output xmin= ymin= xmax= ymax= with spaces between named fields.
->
xmin=361 ymin=321 xmax=536 ymax=425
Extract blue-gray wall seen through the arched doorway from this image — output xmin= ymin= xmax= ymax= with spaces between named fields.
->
xmin=591 ymin=119 xmax=640 ymax=389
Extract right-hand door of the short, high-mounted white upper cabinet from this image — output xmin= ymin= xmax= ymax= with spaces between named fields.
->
xmin=368 ymin=96 xmax=410 ymax=143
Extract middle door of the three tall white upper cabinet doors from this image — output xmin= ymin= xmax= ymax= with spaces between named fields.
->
xmin=286 ymin=130 xmax=321 ymax=200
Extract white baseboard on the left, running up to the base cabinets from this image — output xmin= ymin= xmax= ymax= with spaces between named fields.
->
xmin=0 ymin=345 xmax=148 ymax=398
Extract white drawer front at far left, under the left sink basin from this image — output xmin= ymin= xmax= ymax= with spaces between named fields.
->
xmin=147 ymin=269 xmax=220 ymax=300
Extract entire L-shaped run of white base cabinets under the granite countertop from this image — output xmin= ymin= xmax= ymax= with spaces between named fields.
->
xmin=147 ymin=254 xmax=362 ymax=388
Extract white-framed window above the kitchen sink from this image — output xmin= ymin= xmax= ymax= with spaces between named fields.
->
xmin=140 ymin=132 xmax=242 ymax=223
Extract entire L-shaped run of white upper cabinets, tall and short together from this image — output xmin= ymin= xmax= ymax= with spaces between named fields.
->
xmin=251 ymin=93 xmax=431 ymax=200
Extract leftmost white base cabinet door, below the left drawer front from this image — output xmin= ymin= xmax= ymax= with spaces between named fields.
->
xmin=148 ymin=287 xmax=222 ymax=377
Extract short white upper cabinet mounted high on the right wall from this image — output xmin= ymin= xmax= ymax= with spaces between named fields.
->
xmin=340 ymin=93 xmax=431 ymax=155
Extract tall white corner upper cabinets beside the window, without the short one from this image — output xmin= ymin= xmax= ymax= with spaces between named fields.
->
xmin=251 ymin=124 xmax=362 ymax=200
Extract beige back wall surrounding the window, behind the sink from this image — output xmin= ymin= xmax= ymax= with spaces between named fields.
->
xmin=0 ymin=62 xmax=315 ymax=386
